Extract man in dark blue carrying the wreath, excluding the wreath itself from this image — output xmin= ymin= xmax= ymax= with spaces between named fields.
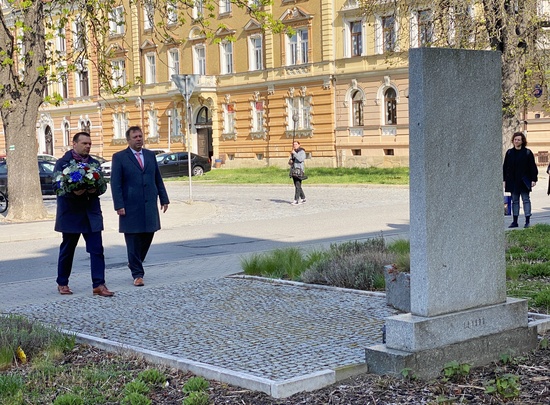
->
xmin=54 ymin=132 xmax=114 ymax=297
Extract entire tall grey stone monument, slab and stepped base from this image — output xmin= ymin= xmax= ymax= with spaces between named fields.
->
xmin=366 ymin=48 xmax=537 ymax=378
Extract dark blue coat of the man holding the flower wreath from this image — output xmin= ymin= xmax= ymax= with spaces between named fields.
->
xmin=54 ymin=151 xmax=103 ymax=233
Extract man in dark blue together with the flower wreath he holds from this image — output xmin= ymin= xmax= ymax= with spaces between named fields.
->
xmin=54 ymin=132 xmax=114 ymax=297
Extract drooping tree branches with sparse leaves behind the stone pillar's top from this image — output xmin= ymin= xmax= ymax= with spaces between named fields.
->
xmin=359 ymin=0 xmax=550 ymax=147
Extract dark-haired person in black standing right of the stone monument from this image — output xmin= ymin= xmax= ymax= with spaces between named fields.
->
xmin=502 ymin=132 xmax=538 ymax=228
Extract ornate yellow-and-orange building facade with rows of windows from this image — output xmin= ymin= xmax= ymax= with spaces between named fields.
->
xmin=0 ymin=0 xmax=550 ymax=167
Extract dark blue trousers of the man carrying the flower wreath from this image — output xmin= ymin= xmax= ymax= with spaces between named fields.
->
xmin=56 ymin=232 xmax=105 ymax=288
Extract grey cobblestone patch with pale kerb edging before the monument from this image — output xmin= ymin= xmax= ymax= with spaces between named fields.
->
xmin=9 ymin=278 xmax=395 ymax=381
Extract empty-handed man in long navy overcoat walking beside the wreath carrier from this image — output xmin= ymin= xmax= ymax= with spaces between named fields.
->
xmin=111 ymin=126 xmax=170 ymax=287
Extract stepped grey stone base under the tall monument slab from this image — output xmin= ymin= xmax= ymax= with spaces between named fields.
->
xmin=365 ymin=298 xmax=538 ymax=379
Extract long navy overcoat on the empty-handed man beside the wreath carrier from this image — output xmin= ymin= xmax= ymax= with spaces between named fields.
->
xmin=111 ymin=148 xmax=170 ymax=233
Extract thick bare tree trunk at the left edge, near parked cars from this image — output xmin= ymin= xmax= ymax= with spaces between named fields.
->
xmin=0 ymin=1 xmax=47 ymax=221
